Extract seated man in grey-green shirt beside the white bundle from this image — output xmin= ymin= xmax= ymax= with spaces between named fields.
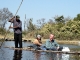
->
xmin=45 ymin=34 xmax=63 ymax=51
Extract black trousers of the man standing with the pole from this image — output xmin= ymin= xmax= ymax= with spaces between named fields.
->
xmin=14 ymin=33 xmax=22 ymax=48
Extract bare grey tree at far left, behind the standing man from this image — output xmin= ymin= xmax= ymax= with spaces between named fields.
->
xmin=0 ymin=8 xmax=13 ymax=28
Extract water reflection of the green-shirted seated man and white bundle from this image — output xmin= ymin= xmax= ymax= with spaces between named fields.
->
xmin=46 ymin=53 xmax=69 ymax=60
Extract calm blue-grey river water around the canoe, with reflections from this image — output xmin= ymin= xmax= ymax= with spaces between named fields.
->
xmin=0 ymin=41 xmax=80 ymax=60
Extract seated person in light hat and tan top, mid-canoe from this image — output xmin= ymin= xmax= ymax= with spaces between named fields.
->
xmin=28 ymin=35 xmax=42 ymax=49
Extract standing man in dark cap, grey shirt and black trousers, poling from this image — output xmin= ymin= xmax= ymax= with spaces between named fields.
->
xmin=9 ymin=15 xmax=22 ymax=48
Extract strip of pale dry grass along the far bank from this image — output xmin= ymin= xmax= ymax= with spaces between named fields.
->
xmin=0 ymin=34 xmax=80 ymax=45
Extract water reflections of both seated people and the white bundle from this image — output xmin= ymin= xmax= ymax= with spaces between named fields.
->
xmin=34 ymin=52 xmax=70 ymax=60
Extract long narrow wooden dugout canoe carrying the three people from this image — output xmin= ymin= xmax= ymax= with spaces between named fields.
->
xmin=5 ymin=46 xmax=80 ymax=55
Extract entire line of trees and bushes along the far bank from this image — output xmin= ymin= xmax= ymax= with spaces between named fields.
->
xmin=0 ymin=8 xmax=80 ymax=40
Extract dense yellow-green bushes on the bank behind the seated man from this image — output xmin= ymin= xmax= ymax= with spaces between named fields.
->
xmin=33 ymin=14 xmax=80 ymax=40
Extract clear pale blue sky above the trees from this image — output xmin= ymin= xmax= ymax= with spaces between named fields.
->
xmin=0 ymin=0 xmax=80 ymax=30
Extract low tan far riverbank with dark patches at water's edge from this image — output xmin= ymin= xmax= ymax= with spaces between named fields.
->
xmin=0 ymin=35 xmax=80 ymax=45
